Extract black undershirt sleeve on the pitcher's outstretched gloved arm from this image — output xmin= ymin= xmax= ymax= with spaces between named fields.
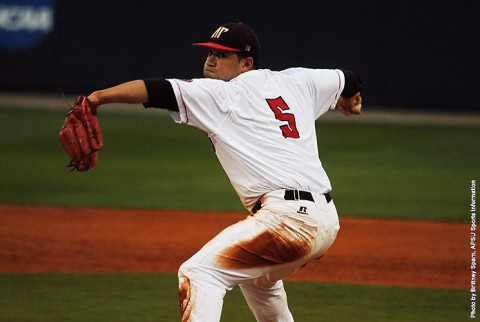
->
xmin=143 ymin=78 xmax=178 ymax=112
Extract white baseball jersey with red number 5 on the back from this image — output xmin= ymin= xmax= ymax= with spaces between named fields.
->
xmin=168 ymin=68 xmax=344 ymax=211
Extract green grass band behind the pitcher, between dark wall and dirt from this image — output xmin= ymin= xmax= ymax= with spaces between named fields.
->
xmin=0 ymin=106 xmax=480 ymax=221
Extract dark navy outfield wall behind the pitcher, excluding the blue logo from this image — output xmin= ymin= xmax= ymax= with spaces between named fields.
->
xmin=0 ymin=0 xmax=480 ymax=109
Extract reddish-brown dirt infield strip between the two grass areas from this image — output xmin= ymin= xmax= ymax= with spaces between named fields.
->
xmin=0 ymin=206 xmax=471 ymax=289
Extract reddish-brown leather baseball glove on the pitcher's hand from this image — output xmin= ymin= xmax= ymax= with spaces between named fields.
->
xmin=59 ymin=96 xmax=103 ymax=171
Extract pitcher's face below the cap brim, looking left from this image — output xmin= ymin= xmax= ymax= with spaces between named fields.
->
xmin=203 ymin=49 xmax=246 ymax=81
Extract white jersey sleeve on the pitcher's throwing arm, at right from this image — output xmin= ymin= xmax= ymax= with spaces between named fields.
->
xmin=286 ymin=68 xmax=345 ymax=119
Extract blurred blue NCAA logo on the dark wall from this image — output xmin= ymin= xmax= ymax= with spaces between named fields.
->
xmin=0 ymin=0 xmax=54 ymax=51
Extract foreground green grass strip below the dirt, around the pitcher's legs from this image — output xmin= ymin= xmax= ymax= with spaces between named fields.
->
xmin=0 ymin=274 xmax=470 ymax=322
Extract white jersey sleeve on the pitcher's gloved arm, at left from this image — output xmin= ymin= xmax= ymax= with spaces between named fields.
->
xmin=168 ymin=79 xmax=240 ymax=134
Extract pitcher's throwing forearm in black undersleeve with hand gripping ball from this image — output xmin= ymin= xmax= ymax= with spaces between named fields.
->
xmin=337 ymin=70 xmax=362 ymax=115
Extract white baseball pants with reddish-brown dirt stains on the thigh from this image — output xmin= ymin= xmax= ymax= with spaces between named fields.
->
xmin=178 ymin=190 xmax=340 ymax=322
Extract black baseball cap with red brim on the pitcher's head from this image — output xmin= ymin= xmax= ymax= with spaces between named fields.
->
xmin=192 ymin=22 xmax=260 ymax=62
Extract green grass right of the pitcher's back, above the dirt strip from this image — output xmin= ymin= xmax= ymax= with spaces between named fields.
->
xmin=317 ymin=119 xmax=480 ymax=221
